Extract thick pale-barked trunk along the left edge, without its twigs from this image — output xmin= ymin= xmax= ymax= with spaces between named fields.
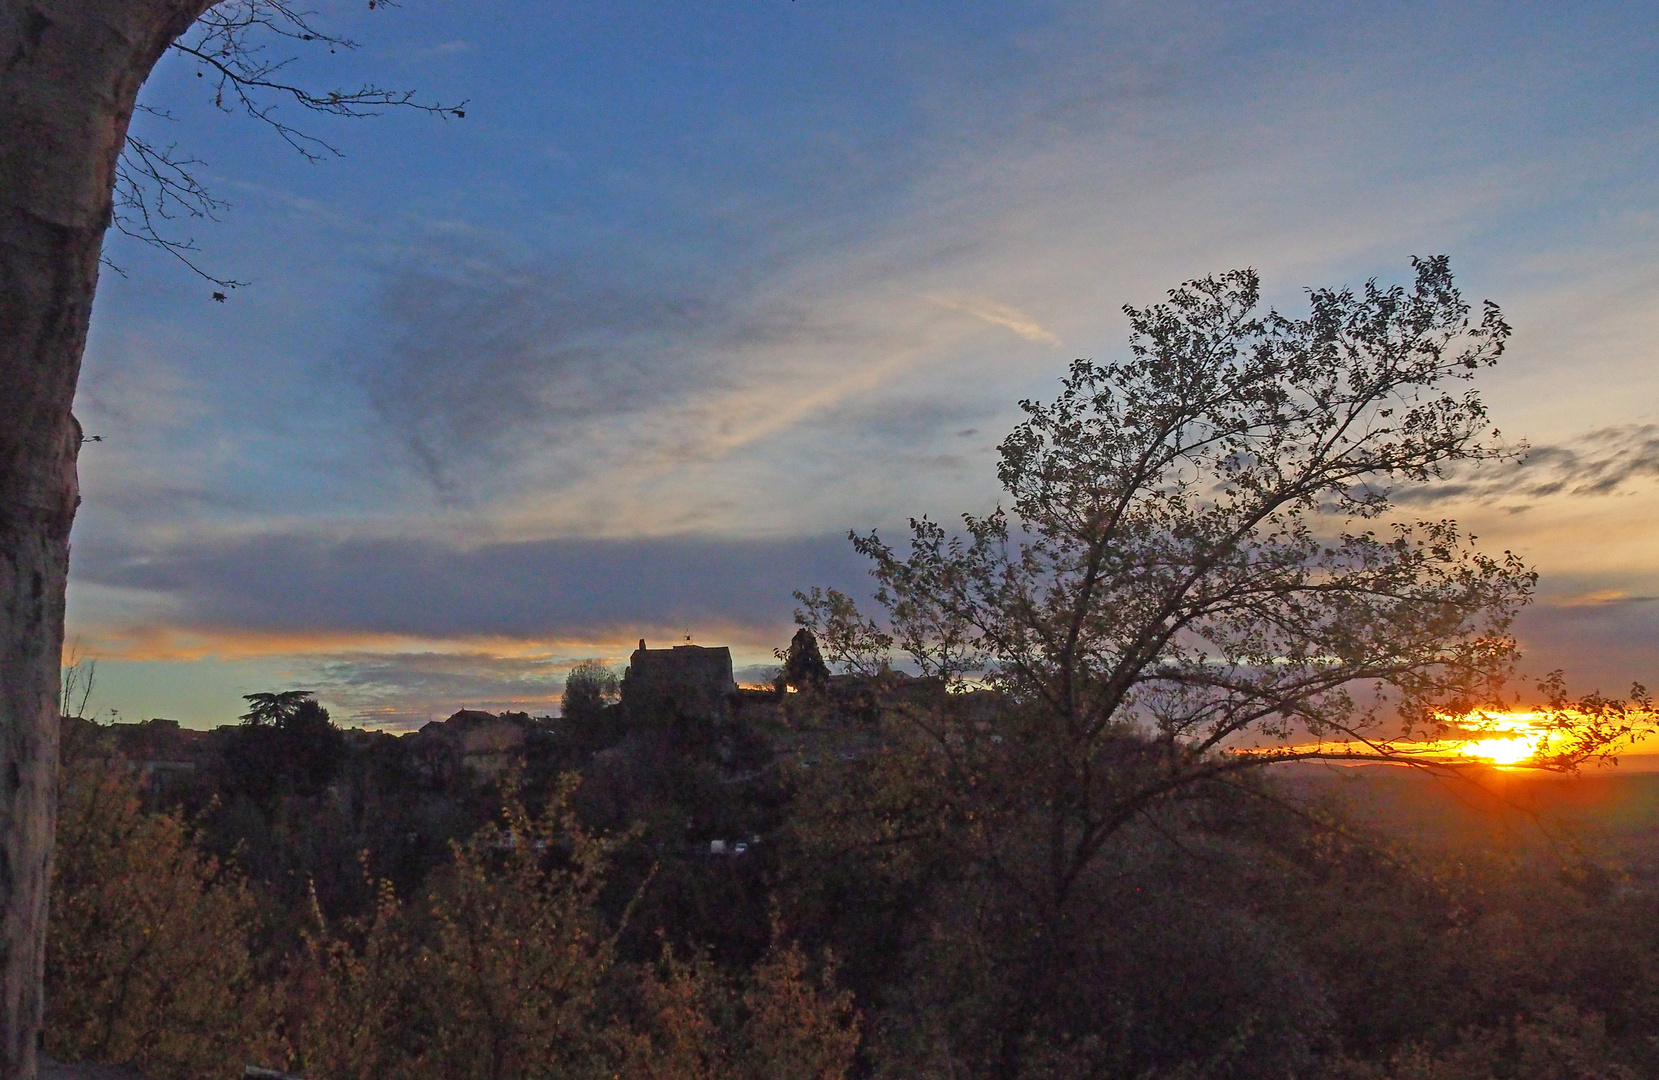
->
xmin=0 ymin=0 xmax=207 ymax=1080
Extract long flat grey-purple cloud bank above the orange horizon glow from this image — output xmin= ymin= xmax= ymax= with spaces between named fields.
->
xmin=78 ymin=534 xmax=864 ymax=640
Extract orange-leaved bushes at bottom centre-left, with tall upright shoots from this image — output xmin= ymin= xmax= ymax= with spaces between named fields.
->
xmin=289 ymin=780 xmax=859 ymax=1080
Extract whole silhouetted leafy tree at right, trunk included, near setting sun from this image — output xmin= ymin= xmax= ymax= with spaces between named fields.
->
xmin=800 ymin=257 xmax=1559 ymax=1080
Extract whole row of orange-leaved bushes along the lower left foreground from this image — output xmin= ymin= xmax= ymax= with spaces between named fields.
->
xmin=46 ymin=760 xmax=859 ymax=1080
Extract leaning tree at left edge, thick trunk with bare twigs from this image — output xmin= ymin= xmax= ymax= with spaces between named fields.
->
xmin=0 ymin=8 xmax=461 ymax=1080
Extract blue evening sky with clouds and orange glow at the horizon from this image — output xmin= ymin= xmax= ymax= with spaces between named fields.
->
xmin=70 ymin=0 xmax=1659 ymax=728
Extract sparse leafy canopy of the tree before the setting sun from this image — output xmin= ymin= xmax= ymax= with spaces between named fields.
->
xmin=800 ymin=257 xmax=1535 ymax=758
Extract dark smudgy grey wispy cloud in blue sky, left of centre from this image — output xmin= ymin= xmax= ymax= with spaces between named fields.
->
xmin=347 ymin=245 xmax=727 ymax=484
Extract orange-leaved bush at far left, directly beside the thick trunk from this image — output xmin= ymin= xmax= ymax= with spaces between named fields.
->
xmin=45 ymin=761 xmax=270 ymax=1080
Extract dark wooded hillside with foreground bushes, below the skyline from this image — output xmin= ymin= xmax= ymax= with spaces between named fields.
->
xmin=48 ymin=669 xmax=1659 ymax=1080
